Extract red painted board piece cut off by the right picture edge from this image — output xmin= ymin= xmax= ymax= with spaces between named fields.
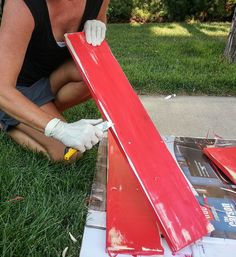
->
xmin=203 ymin=147 xmax=236 ymax=184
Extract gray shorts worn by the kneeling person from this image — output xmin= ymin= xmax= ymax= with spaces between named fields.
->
xmin=0 ymin=78 xmax=55 ymax=131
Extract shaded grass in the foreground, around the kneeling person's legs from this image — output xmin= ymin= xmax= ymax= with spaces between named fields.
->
xmin=0 ymin=101 xmax=99 ymax=257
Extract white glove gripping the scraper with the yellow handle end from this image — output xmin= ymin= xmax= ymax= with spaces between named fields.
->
xmin=44 ymin=118 xmax=103 ymax=153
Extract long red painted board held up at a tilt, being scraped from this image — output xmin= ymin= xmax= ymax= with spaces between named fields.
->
xmin=65 ymin=33 xmax=209 ymax=251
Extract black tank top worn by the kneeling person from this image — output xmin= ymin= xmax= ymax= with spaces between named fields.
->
xmin=17 ymin=0 xmax=103 ymax=86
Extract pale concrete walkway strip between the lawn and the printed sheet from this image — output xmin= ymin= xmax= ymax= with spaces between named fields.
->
xmin=140 ymin=96 xmax=236 ymax=139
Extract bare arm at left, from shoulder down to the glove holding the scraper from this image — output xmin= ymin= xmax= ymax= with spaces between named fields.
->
xmin=0 ymin=0 xmax=54 ymax=132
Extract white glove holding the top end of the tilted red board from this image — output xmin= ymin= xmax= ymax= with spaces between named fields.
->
xmin=84 ymin=20 xmax=106 ymax=46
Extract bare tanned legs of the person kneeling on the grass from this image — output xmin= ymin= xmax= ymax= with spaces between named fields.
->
xmin=9 ymin=60 xmax=90 ymax=161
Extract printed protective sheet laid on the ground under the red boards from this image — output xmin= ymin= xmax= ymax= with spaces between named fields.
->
xmin=80 ymin=136 xmax=236 ymax=257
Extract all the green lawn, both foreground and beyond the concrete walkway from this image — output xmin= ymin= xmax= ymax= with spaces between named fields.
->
xmin=0 ymin=23 xmax=236 ymax=257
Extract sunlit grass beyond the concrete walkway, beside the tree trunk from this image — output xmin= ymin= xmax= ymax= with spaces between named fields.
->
xmin=108 ymin=23 xmax=236 ymax=96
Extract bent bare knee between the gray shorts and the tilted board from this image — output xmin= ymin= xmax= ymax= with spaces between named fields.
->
xmin=50 ymin=60 xmax=91 ymax=112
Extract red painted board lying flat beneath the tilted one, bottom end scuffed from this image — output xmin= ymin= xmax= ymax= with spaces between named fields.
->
xmin=106 ymin=133 xmax=164 ymax=255
